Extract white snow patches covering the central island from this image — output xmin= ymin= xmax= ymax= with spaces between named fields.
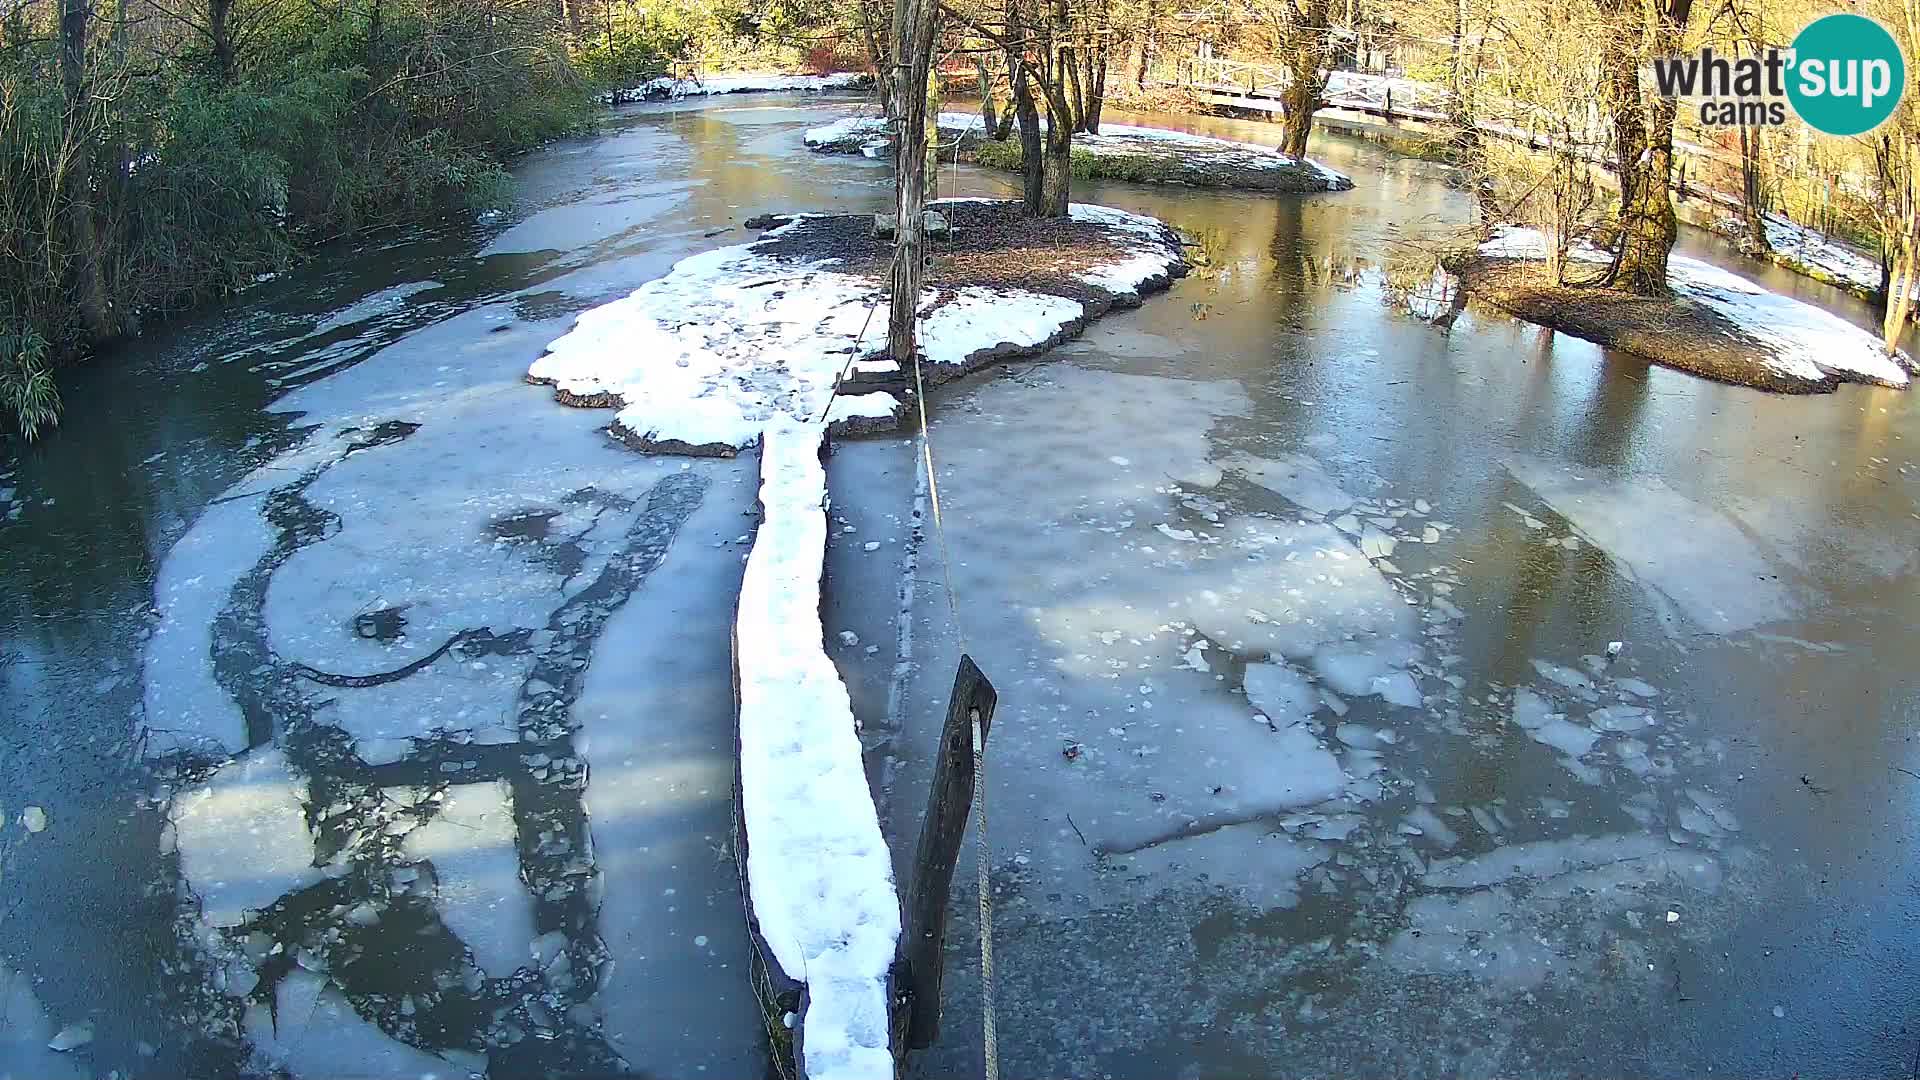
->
xmin=528 ymin=204 xmax=1185 ymax=454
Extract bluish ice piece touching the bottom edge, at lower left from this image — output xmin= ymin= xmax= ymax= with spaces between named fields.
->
xmin=246 ymin=967 xmax=484 ymax=1080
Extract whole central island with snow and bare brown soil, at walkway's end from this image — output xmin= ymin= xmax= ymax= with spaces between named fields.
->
xmin=526 ymin=200 xmax=1187 ymax=455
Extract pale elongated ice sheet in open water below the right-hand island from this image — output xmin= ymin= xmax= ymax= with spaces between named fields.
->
xmin=1507 ymin=457 xmax=1795 ymax=634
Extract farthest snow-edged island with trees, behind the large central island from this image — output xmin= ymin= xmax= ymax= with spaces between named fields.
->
xmin=804 ymin=113 xmax=1354 ymax=194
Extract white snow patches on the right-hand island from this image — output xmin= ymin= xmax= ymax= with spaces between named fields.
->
xmin=1480 ymin=227 xmax=1910 ymax=388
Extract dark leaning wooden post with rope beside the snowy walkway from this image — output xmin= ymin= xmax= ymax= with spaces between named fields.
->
xmin=895 ymin=653 xmax=998 ymax=1055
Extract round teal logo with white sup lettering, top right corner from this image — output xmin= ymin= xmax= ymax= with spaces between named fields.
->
xmin=1788 ymin=15 xmax=1907 ymax=135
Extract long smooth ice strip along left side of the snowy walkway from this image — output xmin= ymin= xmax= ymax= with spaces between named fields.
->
xmin=574 ymin=461 xmax=766 ymax=1076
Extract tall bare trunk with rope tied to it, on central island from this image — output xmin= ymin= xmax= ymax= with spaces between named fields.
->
xmin=887 ymin=0 xmax=939 ymax=365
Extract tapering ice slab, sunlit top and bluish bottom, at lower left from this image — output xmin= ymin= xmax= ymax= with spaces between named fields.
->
xmin=399 ymin=782 xmax=534 ymax=978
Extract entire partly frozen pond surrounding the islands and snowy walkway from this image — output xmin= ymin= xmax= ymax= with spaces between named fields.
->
xmin=0 ymin=98 xmax=1920 ymax=1080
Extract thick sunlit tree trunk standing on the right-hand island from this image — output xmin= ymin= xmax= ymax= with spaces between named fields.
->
xmin=1601 ymin=0 xmax=1693 ymax=296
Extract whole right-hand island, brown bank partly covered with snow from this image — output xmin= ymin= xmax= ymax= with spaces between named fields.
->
xmin=1450 ymin=229 xmax=1920 ymax=394
